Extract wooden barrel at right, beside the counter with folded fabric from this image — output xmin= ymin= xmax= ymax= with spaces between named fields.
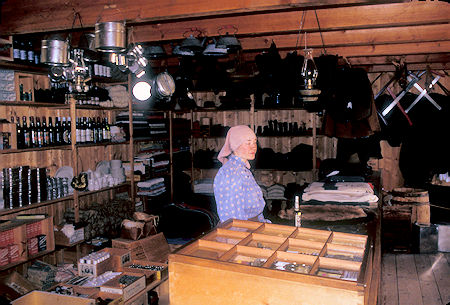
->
xmin=391 ymin=187 xmax=430 ymax=225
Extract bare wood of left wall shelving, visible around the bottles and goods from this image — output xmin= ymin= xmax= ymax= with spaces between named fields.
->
xmin=0 ymin=63 xmax=135 ymax=270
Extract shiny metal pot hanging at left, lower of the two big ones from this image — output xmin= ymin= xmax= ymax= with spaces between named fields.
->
xmin=41 ymin=39 xmax=70 ymax=66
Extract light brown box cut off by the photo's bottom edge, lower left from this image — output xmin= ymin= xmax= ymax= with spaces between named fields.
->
xmin=11 ymin=291 xmax=95 ymax=305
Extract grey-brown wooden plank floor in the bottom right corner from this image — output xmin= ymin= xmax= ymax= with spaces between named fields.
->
xmin=378 ymin=253 xmax=450 ymax=305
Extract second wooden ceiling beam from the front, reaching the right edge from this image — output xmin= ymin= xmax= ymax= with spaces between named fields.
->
xmin=133 ymin=2 xmax=450 ymax=42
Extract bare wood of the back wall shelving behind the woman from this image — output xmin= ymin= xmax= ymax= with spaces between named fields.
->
xmin=183 ymin=102 xmax=337 ymax=184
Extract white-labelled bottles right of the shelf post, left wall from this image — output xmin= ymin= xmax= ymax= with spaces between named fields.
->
xmin=76 ymin=117 xmax=111 ymax=143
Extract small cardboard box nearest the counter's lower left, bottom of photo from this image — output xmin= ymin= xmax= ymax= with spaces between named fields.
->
xmin=100 ymin=272 xmax=145 ymax=301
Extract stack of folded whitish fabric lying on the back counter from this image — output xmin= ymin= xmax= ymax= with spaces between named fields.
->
xmin=302 ymin=182 xmax=378 ymax=203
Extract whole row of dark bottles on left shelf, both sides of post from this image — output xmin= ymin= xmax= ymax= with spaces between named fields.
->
xmin=11 ymin=116 xmax=111 ymax=149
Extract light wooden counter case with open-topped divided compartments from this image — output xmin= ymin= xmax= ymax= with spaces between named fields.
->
xmin=169 ymin=220 xmax=372 ymax=305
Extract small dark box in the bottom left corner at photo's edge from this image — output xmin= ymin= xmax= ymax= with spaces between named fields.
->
xmin=0 ymin=271 xmax=37 ymax=301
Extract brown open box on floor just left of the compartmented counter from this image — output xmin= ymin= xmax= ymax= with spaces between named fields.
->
xmin=112 ymin=233 xmax=170 ymax=262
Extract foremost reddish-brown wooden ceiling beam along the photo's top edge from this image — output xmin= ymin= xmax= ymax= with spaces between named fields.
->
xmin=0 ymin=0 xmax=409 ymax=34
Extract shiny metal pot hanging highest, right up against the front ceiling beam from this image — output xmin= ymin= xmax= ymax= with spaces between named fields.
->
xmin=95 ymin=22 xmax=126 ymax=53
